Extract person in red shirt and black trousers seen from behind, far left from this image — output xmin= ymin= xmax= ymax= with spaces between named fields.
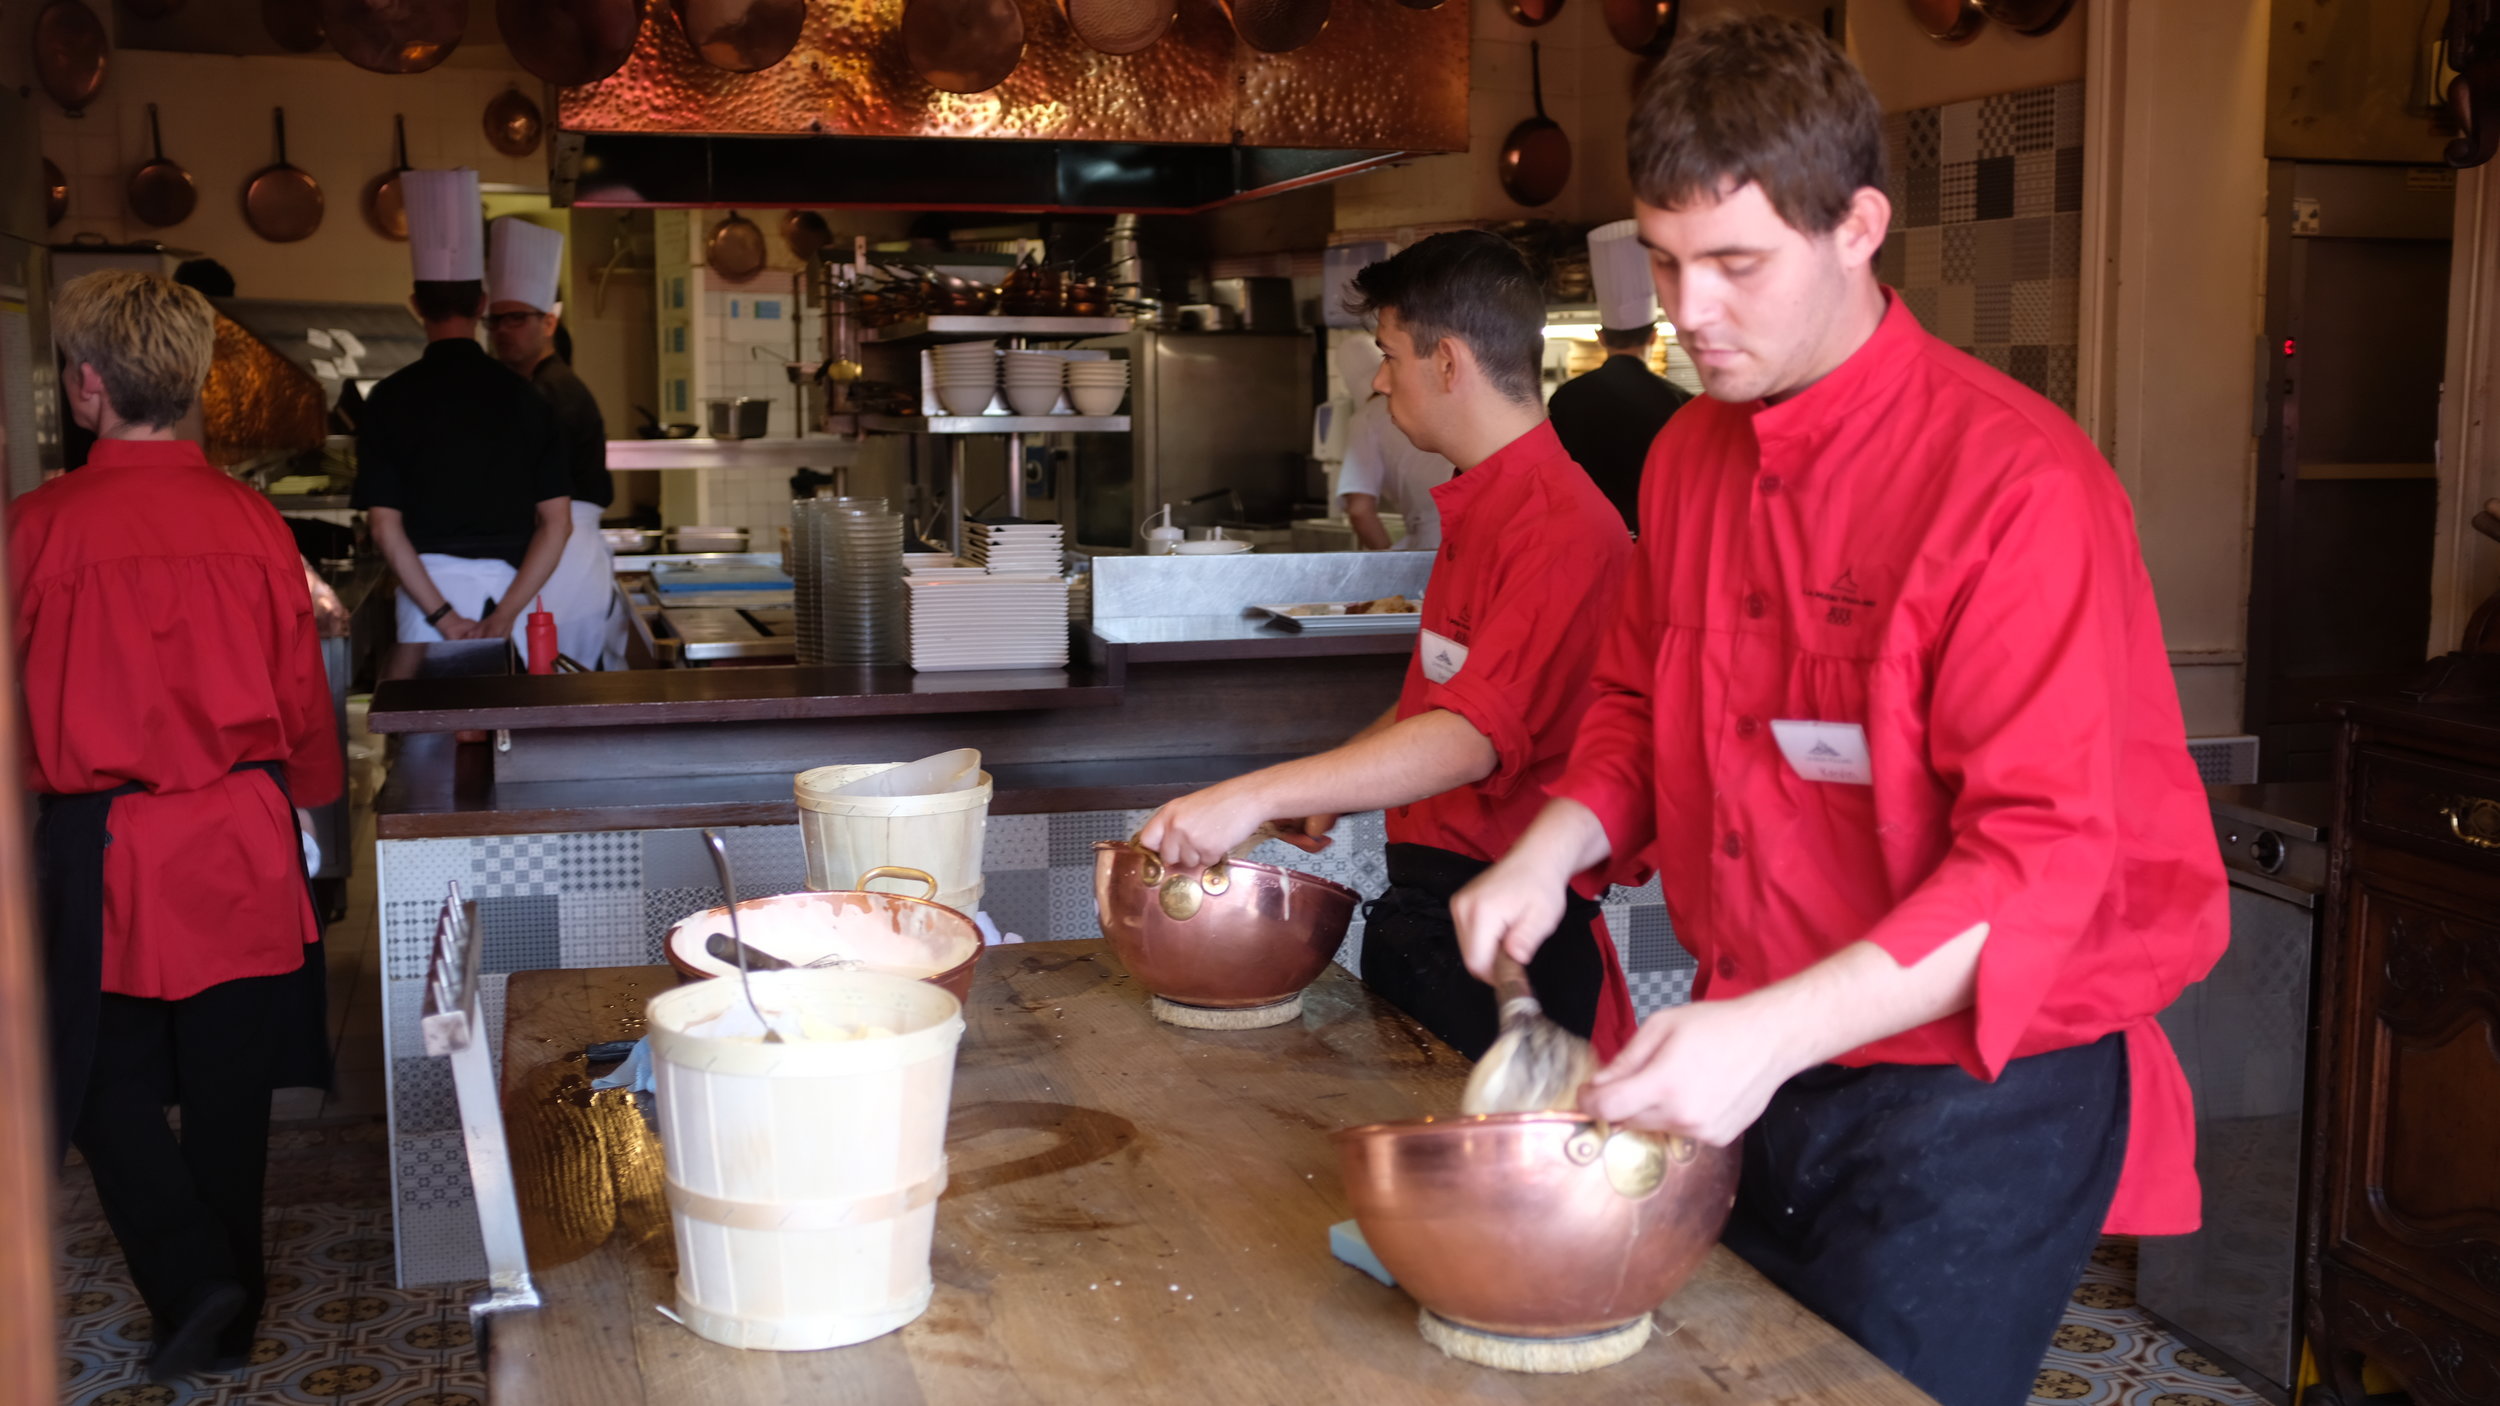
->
xmin=8 ymin=273 xmax=343 ymax=1381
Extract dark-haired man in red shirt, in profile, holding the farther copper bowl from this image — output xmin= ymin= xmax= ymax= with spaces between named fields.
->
xmin=1138 ymin=230 xmax=1633 ymax=1058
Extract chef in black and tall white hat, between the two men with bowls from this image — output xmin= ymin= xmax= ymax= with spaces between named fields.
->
xmin=1545 ymin=220 xmax=1693 ymax=535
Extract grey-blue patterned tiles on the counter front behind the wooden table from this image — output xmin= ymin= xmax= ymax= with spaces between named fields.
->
xmin=378 ymin=811 xmax=1693 ymax=1286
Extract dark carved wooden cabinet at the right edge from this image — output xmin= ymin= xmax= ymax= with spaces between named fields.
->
xmin=2303 ymin=703 xmax=2500 ymax=1406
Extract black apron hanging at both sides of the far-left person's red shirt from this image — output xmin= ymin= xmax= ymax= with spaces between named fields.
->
xmin=35 ymin=761 xmax=330 ymax=1161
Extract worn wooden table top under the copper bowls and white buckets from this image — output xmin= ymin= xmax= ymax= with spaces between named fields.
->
xmin=488 ymin=941 xmax=1930 ymax=1406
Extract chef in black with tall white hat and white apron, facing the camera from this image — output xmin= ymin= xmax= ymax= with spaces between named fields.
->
xmin=485 ymin=215 xmax=625 ymax=668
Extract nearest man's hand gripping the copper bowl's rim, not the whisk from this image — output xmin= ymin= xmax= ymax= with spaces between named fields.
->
xmin=1580 ymin=996 xmax=1813 ymax=1148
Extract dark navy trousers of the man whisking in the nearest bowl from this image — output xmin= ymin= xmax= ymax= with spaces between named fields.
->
xmin=1723 ymin=1036 xmax=2128 ymax=1406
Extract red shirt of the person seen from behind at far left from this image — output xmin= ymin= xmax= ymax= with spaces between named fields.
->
xmin=8 ymin=440 xmax=343 ymax=1001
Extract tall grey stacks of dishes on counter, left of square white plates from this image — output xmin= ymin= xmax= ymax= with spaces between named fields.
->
xmin=790 ymin=498 xmax=908 ymax=663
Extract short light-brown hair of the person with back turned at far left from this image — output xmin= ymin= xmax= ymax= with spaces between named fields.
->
xmin=53 ymin=268 xmax=218 ymax=428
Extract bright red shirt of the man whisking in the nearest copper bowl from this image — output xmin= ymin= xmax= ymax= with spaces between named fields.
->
xmin=1555 ymin=298 xmax=2230 ymax=1233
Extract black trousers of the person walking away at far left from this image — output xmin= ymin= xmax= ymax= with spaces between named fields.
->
xmin=70 ymin=970 xmax=290 ymax=1356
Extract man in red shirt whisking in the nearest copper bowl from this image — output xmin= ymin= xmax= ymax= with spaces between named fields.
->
xmin=1453 ymin=18 xmax=2228 ymax=1406
